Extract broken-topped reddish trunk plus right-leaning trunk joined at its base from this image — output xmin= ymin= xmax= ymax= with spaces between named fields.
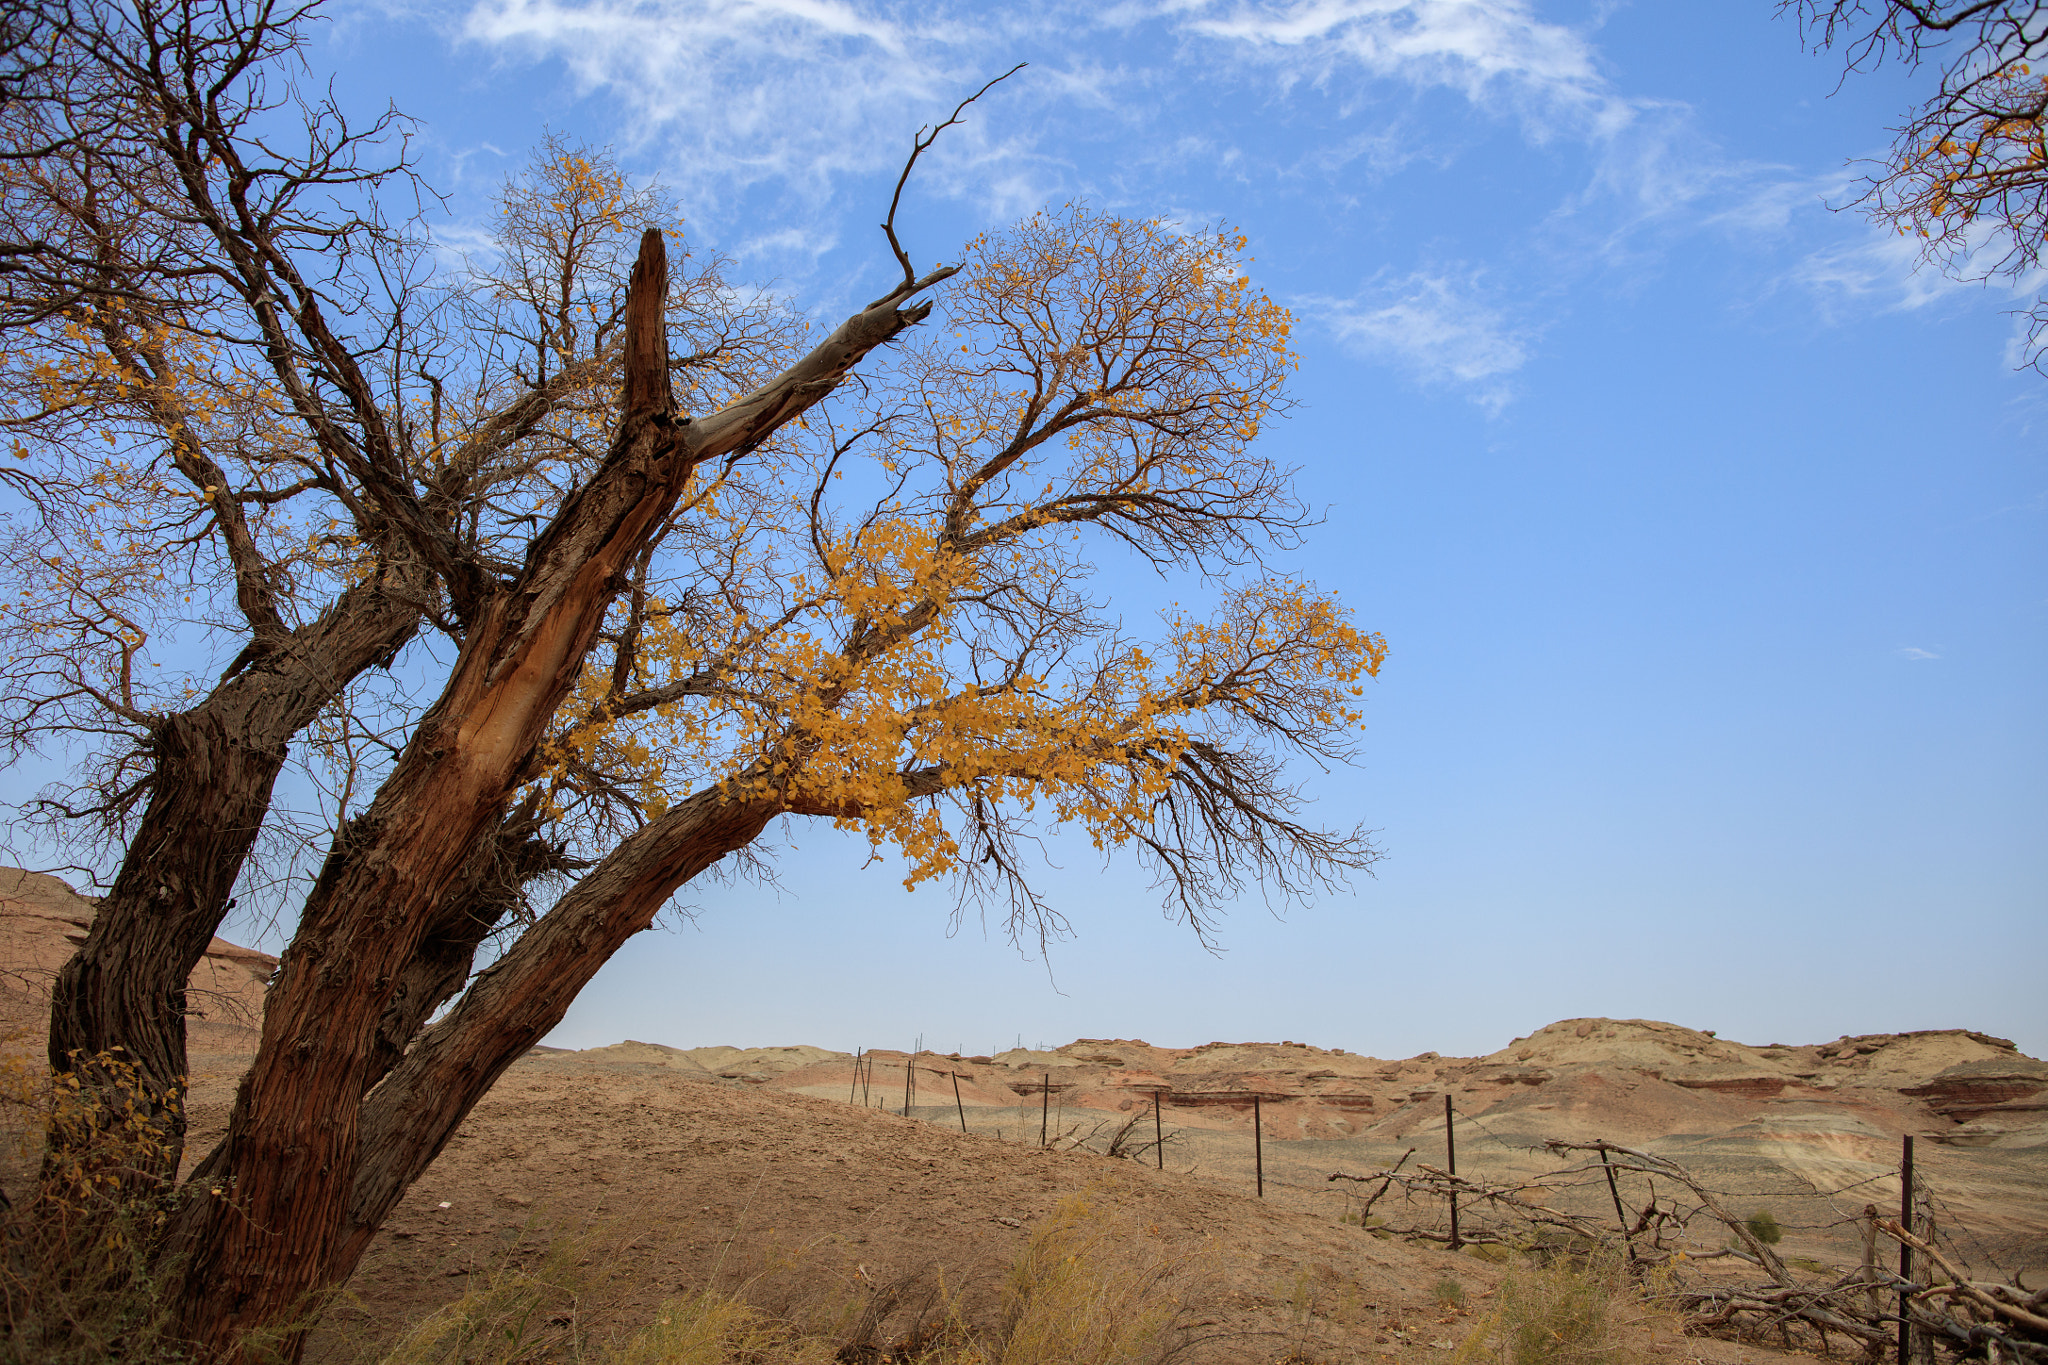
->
xmin=168 ymin=229 xmax=950 ymax=1355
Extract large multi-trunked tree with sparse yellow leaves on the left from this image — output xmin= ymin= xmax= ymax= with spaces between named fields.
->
xmin=0 ymin=0 xmax=1384 ymax=1357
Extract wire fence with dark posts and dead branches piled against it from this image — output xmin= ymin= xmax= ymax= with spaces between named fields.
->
xmin=848 ymin=1052 xmax=2048 ymax=1365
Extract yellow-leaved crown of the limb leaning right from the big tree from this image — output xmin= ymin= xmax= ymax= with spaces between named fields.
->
xmin=541 ymin=207 xmax=1386 ymax=925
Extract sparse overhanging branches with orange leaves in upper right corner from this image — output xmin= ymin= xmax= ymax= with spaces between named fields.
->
xmin=1784 ymin=0 xmax=2048 ymax=366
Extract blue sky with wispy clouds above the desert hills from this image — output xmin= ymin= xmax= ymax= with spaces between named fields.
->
xmin=180 ymin=0 xmax=2048 ymax=1056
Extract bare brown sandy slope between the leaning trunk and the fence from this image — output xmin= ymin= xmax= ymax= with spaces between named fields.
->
xmin=309 ymin=1054 xmax=1780 ymax=1365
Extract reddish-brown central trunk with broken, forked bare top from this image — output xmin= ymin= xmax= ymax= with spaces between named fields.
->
xmin=174 ymin=231 xmax=950 ymax=1355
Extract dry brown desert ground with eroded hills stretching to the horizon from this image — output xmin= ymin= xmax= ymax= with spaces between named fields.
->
xmin=0 ymin=870 xmax=2048 ymax=1363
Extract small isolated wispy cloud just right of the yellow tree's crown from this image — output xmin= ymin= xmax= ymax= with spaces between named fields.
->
xmin=1294 ymin=268 xmax=1532 ymax=411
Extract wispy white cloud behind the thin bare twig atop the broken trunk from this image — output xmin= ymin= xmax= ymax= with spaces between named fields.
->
xmin=459 ymin=0 xmax=1120 ymax=274
